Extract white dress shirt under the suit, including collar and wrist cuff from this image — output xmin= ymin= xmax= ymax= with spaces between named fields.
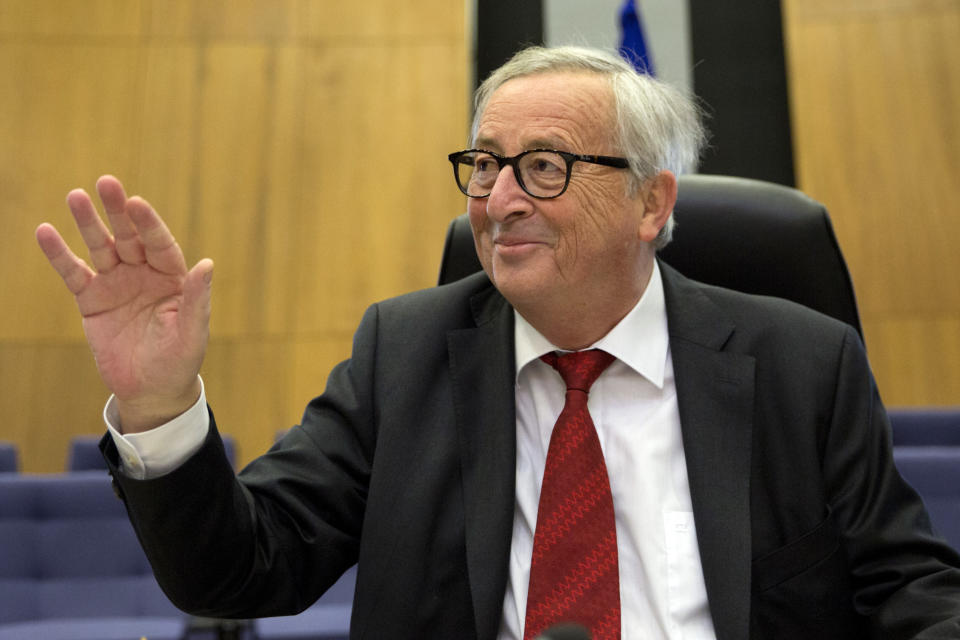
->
xmin=104 ymin=264 xmax=715 ymax=640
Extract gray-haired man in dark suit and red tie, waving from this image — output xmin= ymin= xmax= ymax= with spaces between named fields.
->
xmin=37 ymin=48 xmax=960 ymax=640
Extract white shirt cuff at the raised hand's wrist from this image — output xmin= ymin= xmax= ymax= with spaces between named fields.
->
xmin=103 ymin=379 xmax=210 ymax=480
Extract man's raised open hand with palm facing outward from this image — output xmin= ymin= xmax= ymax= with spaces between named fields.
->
xmin=36 ymin=176 xmax=213 ymax=433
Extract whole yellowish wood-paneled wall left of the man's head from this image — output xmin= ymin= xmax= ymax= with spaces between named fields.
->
xmin=0 ymin=0 xmax=469 ymax=471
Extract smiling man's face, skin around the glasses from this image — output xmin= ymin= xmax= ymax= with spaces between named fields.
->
xmin=468 ymin=72 xmax=653 ymax=313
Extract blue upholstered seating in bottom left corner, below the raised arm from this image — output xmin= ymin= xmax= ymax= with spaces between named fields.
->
xmin=0 ymin=472 xmax=188 ymax=640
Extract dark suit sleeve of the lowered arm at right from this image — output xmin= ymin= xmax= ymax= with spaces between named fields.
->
xmin=823 ymin=329 xmax=960 ymax=639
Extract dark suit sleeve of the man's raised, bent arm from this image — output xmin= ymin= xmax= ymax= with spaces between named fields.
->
xmin=102 ymin=307 xmax=378 ymax=617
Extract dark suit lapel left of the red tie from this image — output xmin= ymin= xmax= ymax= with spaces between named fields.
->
xmin=447 ymin=286 xmax=516 ymax=640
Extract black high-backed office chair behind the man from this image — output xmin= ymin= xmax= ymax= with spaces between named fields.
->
xmin=439 ymin=175 xmax=863 ymax=336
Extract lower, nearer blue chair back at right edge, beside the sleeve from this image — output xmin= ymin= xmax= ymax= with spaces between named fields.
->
xmin=893 ymin=446 xmax=960 ymax=549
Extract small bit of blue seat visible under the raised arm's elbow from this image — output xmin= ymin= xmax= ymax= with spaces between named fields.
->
xmin=254 ymin=566 xmax=357 ymax=640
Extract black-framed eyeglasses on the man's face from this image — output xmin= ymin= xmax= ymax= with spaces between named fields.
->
xmin=447 ymin=149 xmax=630 ymax=199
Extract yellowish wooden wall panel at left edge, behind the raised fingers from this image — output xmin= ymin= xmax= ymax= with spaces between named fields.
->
xmin=0 ymin=37 xmax=139 ymax=340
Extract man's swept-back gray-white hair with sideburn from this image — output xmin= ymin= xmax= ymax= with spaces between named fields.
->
xmin=471 ymin=47 xmax=707 ymax=249
